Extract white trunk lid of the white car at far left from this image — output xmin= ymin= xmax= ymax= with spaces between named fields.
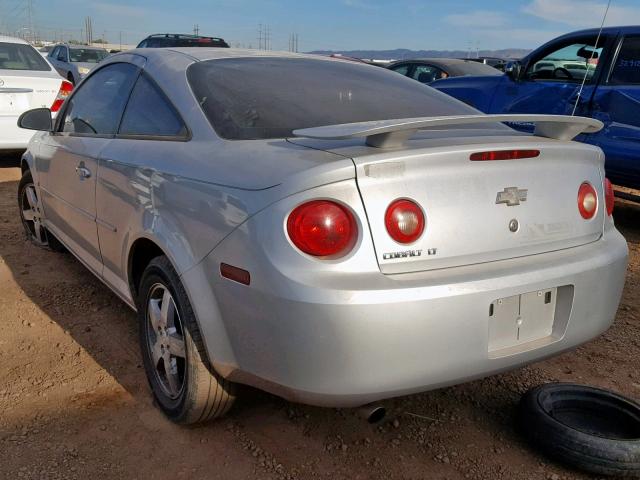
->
xmin=0 ymin=70 xmax=62 ymax=116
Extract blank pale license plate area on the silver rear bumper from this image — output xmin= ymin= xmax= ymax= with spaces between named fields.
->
xmin=489 ymin=288 xmax=558 ymax=352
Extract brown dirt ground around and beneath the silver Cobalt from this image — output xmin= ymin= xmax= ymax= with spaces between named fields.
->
xmin=0 ymin=156 xmax=640 ymax=480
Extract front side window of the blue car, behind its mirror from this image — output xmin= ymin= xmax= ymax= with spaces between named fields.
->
xmin=525 ymin=38 xmax=604 ymax=83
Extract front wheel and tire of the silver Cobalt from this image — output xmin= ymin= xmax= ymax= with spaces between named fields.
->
xmin=18 ymin=170 xmax=67 ymax=252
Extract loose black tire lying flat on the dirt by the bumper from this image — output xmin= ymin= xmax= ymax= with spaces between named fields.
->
xmin=519 ymin=383 xmax=640 ymax=477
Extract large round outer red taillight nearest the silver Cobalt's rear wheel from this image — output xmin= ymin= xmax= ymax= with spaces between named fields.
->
xmin=287 ymin=200 xmax=358 ymax=258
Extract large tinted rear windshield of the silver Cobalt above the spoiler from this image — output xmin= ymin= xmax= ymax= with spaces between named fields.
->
xmin=187 ymin=57 xmax=478 ymax=140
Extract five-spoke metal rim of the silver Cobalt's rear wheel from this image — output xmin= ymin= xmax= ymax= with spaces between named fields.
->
xmin=146 ymin=283 xmax=187 ymax=400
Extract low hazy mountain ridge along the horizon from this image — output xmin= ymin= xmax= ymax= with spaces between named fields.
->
xmin=309 ymin=48 xmax=531 ymax=60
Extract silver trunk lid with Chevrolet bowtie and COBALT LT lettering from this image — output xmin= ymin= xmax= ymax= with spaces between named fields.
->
xmin=296 ymin=131 xmax=605 ymax=274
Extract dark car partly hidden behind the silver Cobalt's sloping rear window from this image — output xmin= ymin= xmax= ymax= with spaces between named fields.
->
xmin=387 ymin=58 xmax=502 ymax=83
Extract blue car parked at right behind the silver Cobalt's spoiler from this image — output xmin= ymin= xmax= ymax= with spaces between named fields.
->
xmin=430 ymin=26 xmax=640 ymax=189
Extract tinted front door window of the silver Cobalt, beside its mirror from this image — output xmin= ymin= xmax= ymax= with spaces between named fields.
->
xmin=61 ymin=63 xmax=138 ymax=135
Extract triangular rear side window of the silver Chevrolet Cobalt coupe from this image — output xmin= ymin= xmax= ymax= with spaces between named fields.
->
xmin=119 ymin=74 xmax=187 ymax=137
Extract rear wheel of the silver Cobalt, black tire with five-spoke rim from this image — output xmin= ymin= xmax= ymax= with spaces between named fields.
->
xmin=138 ymin=256 xmax=235 ymax=424
